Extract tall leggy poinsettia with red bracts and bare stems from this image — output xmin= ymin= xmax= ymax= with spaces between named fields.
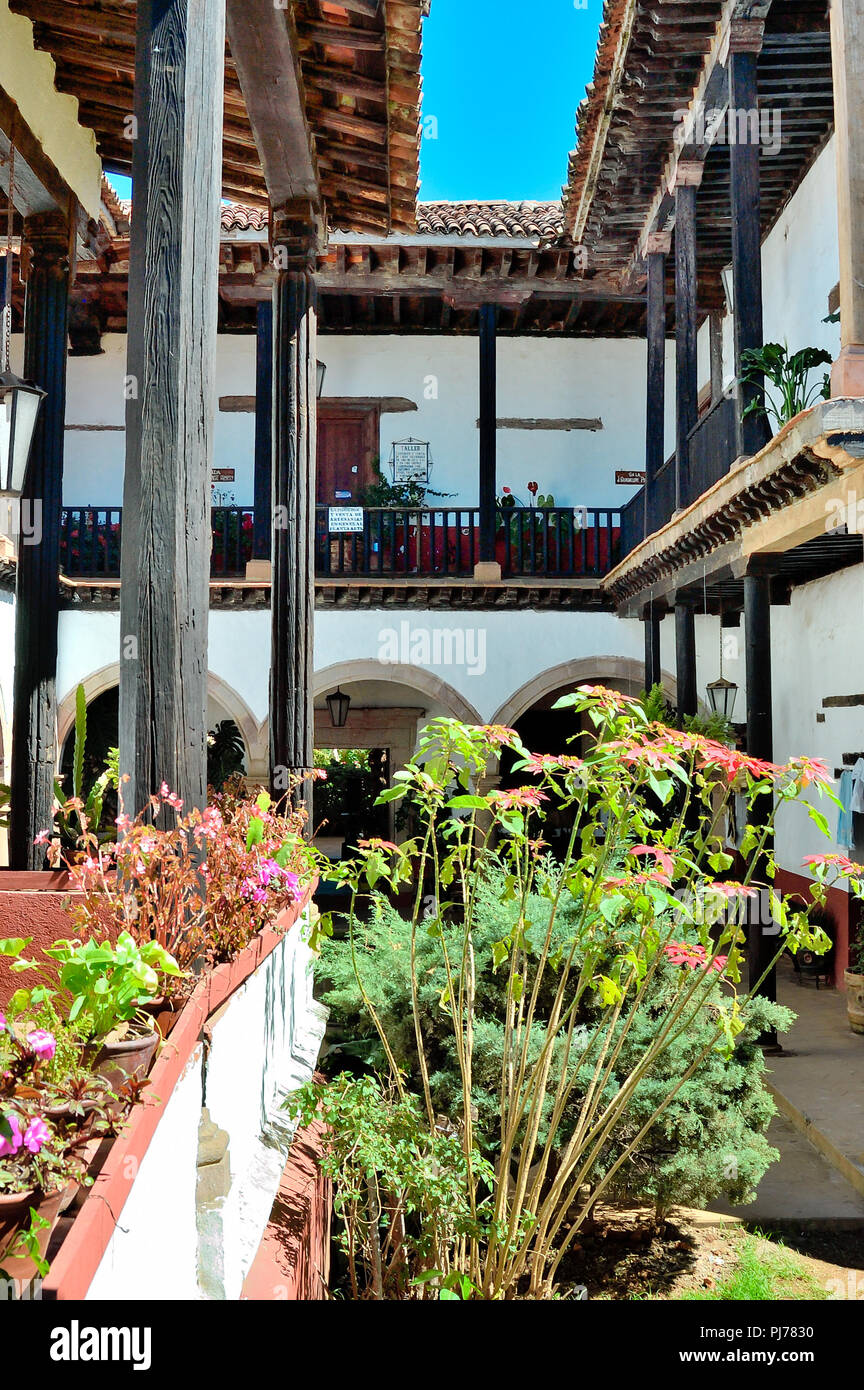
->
xmin=312 ymin=687 xmax=854 ymax=1298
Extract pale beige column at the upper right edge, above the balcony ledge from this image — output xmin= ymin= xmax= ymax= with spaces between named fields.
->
xmin=831 ymin=0 xmax=864 ymax=396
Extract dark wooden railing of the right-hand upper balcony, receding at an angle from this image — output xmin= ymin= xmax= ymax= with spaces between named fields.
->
xmin=621 ymin=396 xmax=738 ymax=555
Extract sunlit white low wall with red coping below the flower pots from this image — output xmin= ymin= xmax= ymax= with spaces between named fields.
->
xmin=88 ymin=924 xmax=326 ymax=1301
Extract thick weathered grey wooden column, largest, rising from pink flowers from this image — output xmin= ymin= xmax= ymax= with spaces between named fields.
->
xmin=119 ymin=0 xmax=225 ymax=815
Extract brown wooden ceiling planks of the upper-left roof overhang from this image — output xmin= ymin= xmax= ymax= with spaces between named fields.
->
xmin=10 ymin=0 xmax=425 ymax=232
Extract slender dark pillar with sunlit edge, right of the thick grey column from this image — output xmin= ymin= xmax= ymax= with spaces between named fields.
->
xmin=269 ymin=239 xmax=318 ymax=798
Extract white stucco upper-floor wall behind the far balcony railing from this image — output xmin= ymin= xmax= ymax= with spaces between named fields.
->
xmin=50 ymin=334 xmax=674 ymax=507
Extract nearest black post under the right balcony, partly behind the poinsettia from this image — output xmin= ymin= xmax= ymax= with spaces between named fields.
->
xmin=745 ymin=571 xmax=779 ymax=1047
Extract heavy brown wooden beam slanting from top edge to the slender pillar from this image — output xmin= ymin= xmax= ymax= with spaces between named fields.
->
xmin=226 ymin=0 xmax=321 ymax=213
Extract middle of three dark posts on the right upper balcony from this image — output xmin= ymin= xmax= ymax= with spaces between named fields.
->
xmin=675 ymin=163 xmax=703 ymax=510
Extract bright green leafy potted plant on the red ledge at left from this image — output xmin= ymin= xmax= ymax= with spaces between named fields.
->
xmin=0 ymin=931 xmax=182 ymax=1038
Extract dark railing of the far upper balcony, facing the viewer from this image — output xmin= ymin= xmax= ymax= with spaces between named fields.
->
xmin=60 ymin=506 xmax=622 ymax=580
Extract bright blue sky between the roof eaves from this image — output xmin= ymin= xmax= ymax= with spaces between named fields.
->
xmin=111 ymin=0 xmax=603 ymax=203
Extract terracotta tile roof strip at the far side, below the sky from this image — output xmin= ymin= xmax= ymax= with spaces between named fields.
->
xmin=222 ymin=202 xmax=563 ymax=240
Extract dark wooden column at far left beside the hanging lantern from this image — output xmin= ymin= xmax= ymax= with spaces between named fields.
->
xmin=8 ymin=213 xmax=69 ymax=869
